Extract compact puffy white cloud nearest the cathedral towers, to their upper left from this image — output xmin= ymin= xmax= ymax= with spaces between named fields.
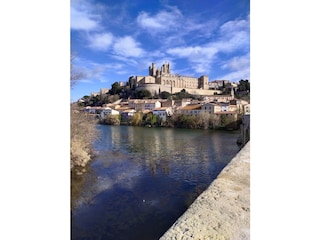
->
xmin=113 ymin=36 xmax=145 ymax=57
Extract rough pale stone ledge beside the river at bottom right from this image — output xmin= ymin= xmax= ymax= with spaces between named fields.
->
xmin=160 ymin=142 xmax=250 ymax=240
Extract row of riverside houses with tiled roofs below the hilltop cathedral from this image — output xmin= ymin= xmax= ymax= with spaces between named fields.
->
xmin=84 ymin=94 xmax=250 ymax=124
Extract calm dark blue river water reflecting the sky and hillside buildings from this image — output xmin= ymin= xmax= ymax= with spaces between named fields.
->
xmin=71 ymin=125 xmax=239 ymax=240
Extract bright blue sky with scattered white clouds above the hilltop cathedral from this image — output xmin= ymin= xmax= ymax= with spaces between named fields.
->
xmin=70 ymin=0 xmax=250 ymax=101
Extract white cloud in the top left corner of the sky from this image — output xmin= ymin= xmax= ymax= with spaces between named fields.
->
xmin=70 ymin=6 xmax=99 ymax=31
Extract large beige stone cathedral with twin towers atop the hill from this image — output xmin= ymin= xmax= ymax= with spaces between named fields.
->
xmin=129 ymin=63 xmax=221 ymax=95
